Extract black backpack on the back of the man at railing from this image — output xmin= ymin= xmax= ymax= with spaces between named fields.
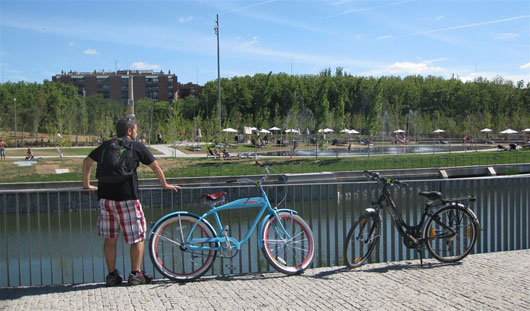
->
xmin=96 ymin=138 xmax=137 ymax=183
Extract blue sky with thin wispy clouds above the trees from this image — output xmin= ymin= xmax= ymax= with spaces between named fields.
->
xmin=0 ymin=0 xmax=530 ymax=84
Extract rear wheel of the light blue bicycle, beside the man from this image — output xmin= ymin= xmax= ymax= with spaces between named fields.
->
xmin=149 ymin=214 xmax=217 ymax=282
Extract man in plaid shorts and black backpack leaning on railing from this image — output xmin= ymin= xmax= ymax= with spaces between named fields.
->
xmin=83 ymin=119 xmax=180 ymax=286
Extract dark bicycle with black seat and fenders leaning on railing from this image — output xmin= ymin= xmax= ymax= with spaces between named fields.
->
xmin=344 ymin=171 xmax=481 ymax=269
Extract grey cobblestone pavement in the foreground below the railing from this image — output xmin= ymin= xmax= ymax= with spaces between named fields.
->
xmin=0 ymin=250 xmax=530 ymax=311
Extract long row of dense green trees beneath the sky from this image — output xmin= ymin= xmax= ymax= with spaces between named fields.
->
xmin=0 ymin=68 xmax=530 ymax=146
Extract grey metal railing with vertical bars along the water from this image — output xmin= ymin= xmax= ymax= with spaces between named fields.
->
xmin=0 ymin=175 xmax=530 ymax=286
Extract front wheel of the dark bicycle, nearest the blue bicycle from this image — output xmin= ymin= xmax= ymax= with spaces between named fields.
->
xmin=344 ymin=214 xmax=381 ymax=269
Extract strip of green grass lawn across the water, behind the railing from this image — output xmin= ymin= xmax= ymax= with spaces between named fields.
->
xmin=0 ymin=148 xmax=530 ymax=183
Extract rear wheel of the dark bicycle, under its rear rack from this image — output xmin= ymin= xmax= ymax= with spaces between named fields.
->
xmin=423 ymin=205 xmax=478 ymax=263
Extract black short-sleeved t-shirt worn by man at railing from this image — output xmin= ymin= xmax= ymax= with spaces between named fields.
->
xmin=88 ymin=141 xmax=156 ymax=201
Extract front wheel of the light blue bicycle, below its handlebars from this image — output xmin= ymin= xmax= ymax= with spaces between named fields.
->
xmin=261 ymin=212 xmax=315 ymax=275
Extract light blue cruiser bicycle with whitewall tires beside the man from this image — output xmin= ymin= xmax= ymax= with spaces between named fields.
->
xmin=149 ymin=161 xmax=315 ymax=282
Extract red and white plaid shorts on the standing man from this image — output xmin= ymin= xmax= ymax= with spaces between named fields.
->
xmin=97 ymin=199 xmax=146 ymax=244
